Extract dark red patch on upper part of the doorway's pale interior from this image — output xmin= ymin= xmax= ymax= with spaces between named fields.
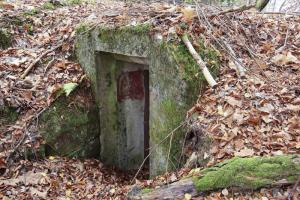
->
xmin=117 ymin=70 xmax=145 ymax=102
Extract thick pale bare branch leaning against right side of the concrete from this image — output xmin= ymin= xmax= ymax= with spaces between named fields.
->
xmin=182 ymin=34 xmax=217 ymax=87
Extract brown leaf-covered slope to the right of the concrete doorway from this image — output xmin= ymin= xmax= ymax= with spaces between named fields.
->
xmin=189 ymin=5 xmax=300 ymax=165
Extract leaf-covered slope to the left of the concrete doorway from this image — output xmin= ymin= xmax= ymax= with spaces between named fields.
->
xmin=0 ymin=1 xmax=96 ymax=161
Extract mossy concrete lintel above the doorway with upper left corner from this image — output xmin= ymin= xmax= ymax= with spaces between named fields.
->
xmin=76 ymin=24 xmax=150 ymax=91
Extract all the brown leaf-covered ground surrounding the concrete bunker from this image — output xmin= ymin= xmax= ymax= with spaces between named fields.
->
xmin=0 ymin=0 xmax=300 ymax=200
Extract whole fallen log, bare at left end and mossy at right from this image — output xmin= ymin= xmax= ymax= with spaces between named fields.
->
xmin=129 ymin=155 xmax=300 ymax=200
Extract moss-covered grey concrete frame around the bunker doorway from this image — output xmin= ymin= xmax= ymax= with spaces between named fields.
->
xmin=76 ymin=24 xmax=219 ymax=176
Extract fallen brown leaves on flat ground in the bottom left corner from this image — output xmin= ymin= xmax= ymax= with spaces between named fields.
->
xmin=0 ymin=156 xmax=137 ymax=199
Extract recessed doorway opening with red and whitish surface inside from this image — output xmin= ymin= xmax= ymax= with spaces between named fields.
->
xmin=96 ymin=52 xmax=149 ymax=170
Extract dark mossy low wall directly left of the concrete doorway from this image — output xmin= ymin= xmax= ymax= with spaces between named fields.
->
xmin=39 ymin=85 xmax=100 ymax=158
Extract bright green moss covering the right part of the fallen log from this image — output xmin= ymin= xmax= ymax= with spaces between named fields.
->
xmin=194 ymin=155 xmax=300 ymax=192
